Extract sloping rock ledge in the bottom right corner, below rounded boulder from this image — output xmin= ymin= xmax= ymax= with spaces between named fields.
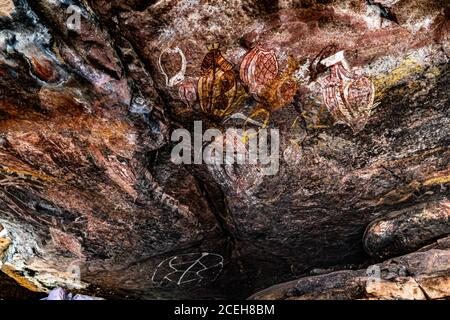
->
xmin=250 ymin=238 xmax=450 ymax=300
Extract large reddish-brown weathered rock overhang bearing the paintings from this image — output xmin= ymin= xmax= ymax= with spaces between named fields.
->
xmin=0 ymin=0 xmax=450 ymax=298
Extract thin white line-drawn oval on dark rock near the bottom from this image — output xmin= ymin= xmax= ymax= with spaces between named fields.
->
xmin=152 ymin=252 xmax=224 ymax=287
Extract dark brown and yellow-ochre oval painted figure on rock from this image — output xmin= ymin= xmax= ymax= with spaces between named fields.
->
xmin=198 ymin=43 xmax=237 ymax=118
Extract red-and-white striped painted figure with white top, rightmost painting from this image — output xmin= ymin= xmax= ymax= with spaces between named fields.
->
xmin=319 ymin=51 xmax=375 ymax=133
